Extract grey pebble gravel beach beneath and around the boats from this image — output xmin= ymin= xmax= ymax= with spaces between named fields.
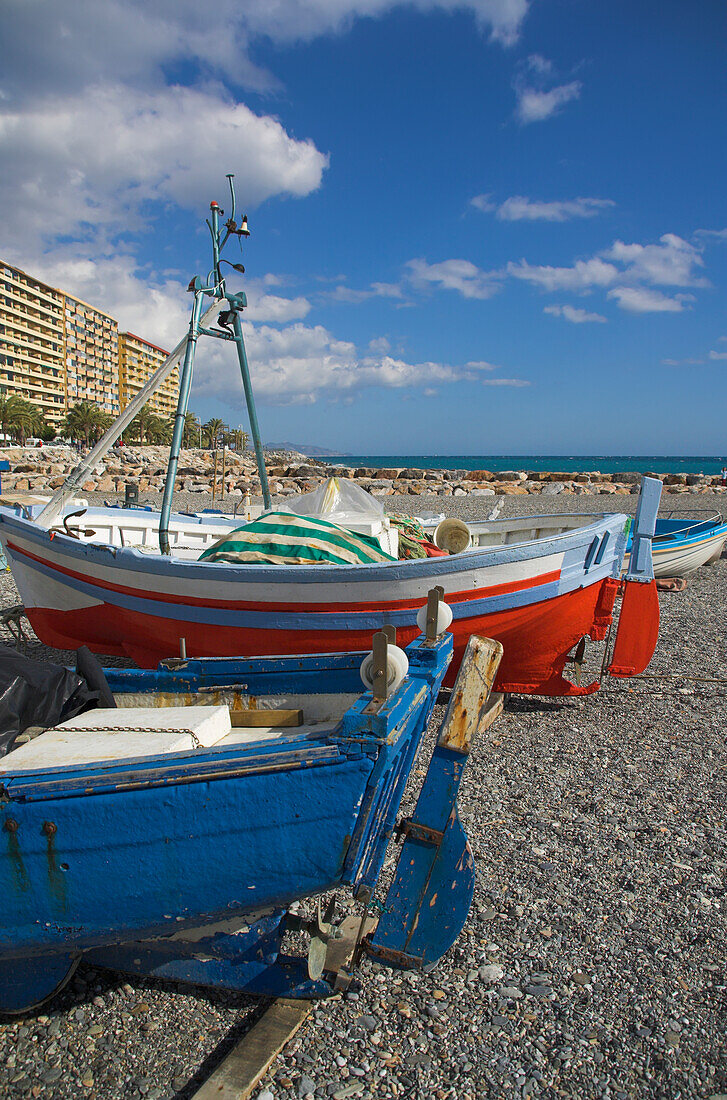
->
xmin=0 ymin=494 xmax=727 ymax=1100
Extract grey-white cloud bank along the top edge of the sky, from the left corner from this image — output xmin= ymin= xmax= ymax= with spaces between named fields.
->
xmin=0 ymin=0 xmax=528 ymax=106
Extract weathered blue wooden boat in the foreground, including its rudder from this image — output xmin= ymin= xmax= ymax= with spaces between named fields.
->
xmin=0 ymin=604 xmax=502 ymax=1012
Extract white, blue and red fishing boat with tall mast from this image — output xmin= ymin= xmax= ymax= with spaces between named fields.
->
xmin=0 ymin=180 xmax=661 ymax=695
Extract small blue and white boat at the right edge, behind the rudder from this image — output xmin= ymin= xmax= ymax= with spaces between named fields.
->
xmin=624 ymin=512 xmax=727 ymax=576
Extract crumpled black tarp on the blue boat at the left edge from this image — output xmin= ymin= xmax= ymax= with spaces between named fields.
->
xmin=0 ymin=642 xmax=106 ymax=757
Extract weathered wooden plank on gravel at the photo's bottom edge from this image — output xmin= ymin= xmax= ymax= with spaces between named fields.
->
xmin=190 ymin=997 xmax=312 ymax=1100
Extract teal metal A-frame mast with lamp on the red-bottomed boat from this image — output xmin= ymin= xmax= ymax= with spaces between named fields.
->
xmin=159 ymin=174 xmax=271 ymax=554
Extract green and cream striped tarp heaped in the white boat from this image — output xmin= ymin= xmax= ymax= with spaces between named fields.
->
xmin=199 ymin=512 xmax=396 ymax=565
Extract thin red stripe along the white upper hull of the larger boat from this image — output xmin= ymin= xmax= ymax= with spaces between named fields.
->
xmin=8 ymin=539 xmax=561 ymax=614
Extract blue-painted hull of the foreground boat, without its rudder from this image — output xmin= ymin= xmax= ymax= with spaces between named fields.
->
xmin=0 ymin=635 xmax=459 ymax=1011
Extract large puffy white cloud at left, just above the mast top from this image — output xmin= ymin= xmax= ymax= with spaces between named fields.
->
xmin=0 ymin=86 xmax=328 ymax=243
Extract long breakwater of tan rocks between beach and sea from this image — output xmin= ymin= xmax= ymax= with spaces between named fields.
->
xmin=0 ymin=447 xmax=725 ymax=497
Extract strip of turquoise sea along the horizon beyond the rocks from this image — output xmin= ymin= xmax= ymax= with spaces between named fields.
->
xmin=316 ymin=454 xmax=727 ymax=474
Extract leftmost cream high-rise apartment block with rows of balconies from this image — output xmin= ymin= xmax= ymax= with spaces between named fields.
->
xmin=0 ymin=261 xmax=66 ymax=424
